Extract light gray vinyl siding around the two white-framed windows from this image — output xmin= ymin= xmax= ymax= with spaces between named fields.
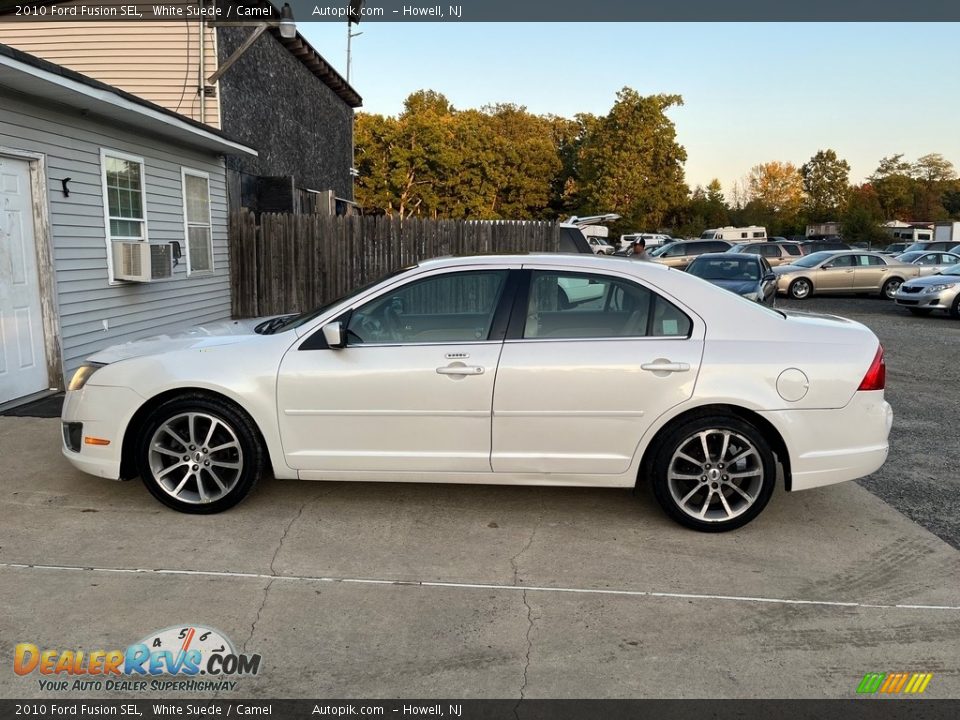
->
xmin=0 ymin=88 xmax=230 ymax=376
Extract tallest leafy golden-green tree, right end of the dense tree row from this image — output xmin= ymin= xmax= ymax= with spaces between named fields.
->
xmin=578 ymin=88 xmax=688 ymax=230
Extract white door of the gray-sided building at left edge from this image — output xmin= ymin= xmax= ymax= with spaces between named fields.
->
xmin=0 ymin=157 xmax=49 ymax=403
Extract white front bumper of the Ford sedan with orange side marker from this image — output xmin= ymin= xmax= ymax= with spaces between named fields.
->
xmin=61 ymin=383 xmax=144 ymax=480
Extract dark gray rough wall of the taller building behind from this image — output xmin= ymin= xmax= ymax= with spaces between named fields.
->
xmin=217 ymin=27 xmax=353 ymax=200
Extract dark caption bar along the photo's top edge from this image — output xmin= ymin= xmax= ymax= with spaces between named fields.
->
xmin=0 ymin=0 xmax=960 ymax=22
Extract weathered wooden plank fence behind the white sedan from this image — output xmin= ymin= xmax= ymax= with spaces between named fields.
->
xmin=230 ymin=210 xmax=560 ymax=318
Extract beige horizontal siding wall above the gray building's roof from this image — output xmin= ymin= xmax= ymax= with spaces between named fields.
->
xmin=0 ymin=17 xmax=220 ymax=128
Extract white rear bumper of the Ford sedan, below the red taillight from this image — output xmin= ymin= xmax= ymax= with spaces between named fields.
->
xmin=760 ymin=391 xmax=893 ymax=490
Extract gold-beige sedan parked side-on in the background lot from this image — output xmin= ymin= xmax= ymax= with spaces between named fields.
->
xmin=773 ymin=250 xmax=920 ymax=300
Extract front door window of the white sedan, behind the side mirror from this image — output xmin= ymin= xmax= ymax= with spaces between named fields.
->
xmin=347 ymin=270 xmax=509 ymax=345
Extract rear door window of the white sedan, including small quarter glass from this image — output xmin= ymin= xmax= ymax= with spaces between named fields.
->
xmin=523 ymin=270 xmax=693 ymax=340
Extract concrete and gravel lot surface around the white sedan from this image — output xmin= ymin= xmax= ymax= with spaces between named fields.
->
xmin=0 ymin=297 xmax=960 ymax=698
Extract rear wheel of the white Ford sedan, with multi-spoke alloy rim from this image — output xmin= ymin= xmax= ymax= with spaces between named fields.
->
xmin=650 ymin=415 xmax=777 ymax=532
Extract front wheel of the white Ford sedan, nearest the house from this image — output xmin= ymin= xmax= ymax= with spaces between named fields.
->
xmin=135 ymin=395 xmax=264 ymax=515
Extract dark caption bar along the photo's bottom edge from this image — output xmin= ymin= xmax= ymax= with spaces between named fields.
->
xmin=0 ymin=696 xmax=960 ymax=720
